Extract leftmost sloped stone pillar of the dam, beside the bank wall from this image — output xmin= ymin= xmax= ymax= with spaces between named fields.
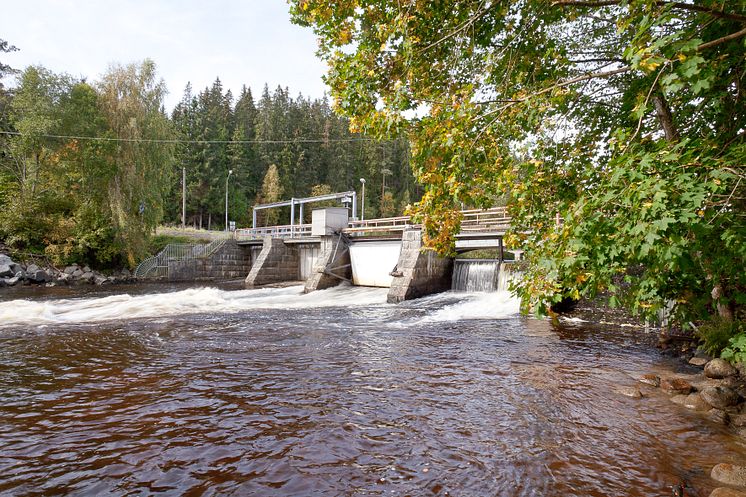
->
xmin=245 ymin=236 xmax=300 ymax=287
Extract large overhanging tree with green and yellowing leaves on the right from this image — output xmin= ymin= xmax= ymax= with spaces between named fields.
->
xmin=291 ymin=0 xmax=746 ymax=322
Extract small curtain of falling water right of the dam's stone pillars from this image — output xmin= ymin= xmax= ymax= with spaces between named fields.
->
xmin=451 ymin=259 xmax=514 ymax=292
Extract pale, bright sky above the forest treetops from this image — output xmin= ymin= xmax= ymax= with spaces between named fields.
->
xmin=0 ymin=0 xmax=328 ymax=110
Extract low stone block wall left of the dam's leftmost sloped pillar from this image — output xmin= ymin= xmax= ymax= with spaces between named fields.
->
xmin=168 ymin=240 xmax=251 ymax=281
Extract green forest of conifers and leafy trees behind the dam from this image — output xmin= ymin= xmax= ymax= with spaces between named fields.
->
xmin=0 ymin=47 xmax=420 ymax=267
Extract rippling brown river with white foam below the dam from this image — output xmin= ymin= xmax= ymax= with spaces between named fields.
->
xmin=0 ymin=280 xmax=746 ymax=496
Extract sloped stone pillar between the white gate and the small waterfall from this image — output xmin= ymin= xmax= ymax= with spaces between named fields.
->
xmin=387 ymin=229 xmax=453 ymax=304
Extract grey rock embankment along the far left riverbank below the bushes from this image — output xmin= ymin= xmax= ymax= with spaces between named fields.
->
xmin=0 ymin=254 xmax=133 ymax=288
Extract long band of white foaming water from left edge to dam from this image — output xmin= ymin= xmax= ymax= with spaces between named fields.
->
xmin=0 ymin=285 xmax=388 ymax=327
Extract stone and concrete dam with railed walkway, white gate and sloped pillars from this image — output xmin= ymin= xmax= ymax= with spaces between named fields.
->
xmin=138 ymin=207 xmax=521 ymax=302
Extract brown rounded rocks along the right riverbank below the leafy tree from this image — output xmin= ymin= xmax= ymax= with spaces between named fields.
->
xmin=632 ymin=356 xmax=746 ymax=497
